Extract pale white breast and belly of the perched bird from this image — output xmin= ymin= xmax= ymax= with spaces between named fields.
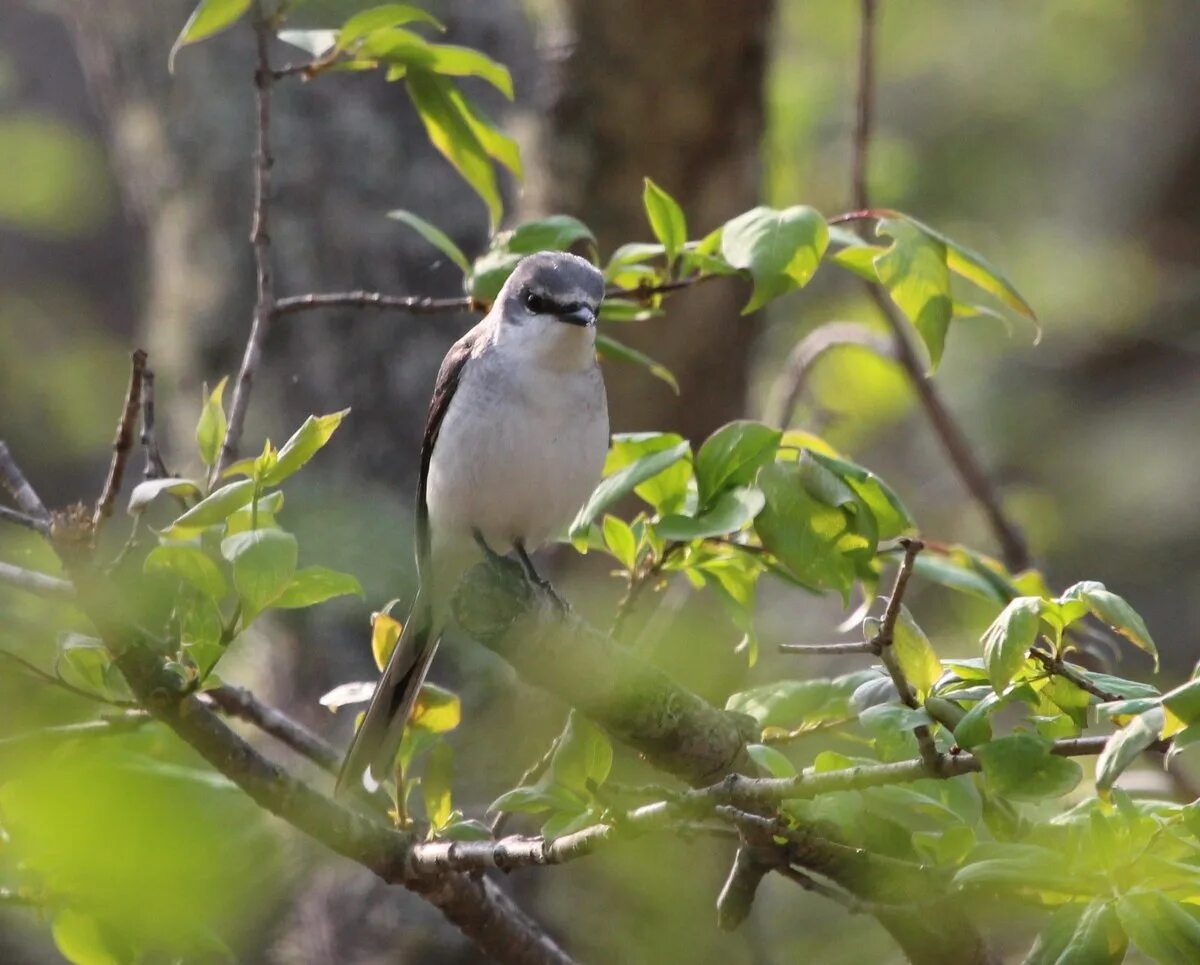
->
xmin=426 ymin=352 xmax=608 ymax=566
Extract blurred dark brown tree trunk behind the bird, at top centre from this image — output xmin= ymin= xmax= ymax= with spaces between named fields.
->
xmin=529 ymin=0 xmax=773 ymax=438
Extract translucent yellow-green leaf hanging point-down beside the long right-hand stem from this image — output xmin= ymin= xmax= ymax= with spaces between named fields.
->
xmin=875 ymin=218 xmax=953 ymax=372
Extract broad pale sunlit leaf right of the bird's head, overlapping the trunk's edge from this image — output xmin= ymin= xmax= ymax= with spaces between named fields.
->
xmin=721 ymin=205 xmax=829 ymax=314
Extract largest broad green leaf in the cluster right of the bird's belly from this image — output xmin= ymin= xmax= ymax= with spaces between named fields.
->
xmin=755 ymin=462 xmax=856 ymax=599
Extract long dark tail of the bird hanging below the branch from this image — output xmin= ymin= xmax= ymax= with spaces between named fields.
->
xmin=335 ymin=592 xmax=440 ymax=795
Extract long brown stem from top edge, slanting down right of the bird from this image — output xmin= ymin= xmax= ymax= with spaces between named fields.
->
xmin=830 ymin=0 xmax=1030 ymax=573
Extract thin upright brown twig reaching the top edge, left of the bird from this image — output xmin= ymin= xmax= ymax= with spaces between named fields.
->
xmin=209 ymin=7 xmax=276 ymax=484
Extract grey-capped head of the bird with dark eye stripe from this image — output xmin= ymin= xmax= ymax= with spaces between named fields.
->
xmin=493 ymin=251 xmax=604 ymax=365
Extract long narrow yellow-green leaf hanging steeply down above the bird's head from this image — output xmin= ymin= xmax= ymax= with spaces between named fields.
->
xmin=404 ymin=70 xmax=502 ymax=224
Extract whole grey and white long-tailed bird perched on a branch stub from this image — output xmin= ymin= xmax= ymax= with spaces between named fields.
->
xmin=337 ymin=252 xmax=608 ymax=792
